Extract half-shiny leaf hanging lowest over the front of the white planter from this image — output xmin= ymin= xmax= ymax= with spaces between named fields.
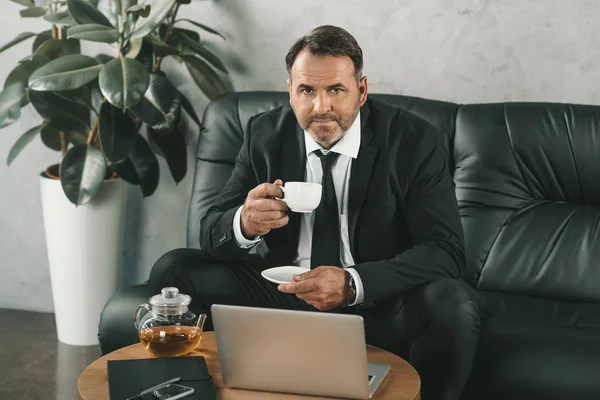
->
xmin=60 ymin=144 xmax=106 ymax=206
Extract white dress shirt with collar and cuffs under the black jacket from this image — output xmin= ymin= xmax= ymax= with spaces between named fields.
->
xmin=233 ymin=113 xmax=365 ymax=305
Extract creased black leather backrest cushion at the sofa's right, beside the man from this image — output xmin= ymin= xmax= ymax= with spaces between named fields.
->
xmin=454 ymin=103 xmax=600 ymax=302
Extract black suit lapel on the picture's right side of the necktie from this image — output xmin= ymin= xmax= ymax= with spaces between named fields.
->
xmin=348 ymin=103 xmax=379 ymax=262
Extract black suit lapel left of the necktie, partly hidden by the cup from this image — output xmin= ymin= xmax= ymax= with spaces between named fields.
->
xmin=281 ymin=123 xmax=306 ymax=258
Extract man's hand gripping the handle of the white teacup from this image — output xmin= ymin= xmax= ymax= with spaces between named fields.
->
xmin=241 ymin=179 xmax=289 ymax=238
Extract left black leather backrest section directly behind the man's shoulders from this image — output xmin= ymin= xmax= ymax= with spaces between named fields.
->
xmin=187 ymin=92 xmax=457 ymax=248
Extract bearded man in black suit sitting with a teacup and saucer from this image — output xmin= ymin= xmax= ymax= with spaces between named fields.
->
xmin=150 ymin=26 xmax=479 ymax=400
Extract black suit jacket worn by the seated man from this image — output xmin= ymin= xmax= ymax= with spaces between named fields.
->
xmin=200 ymin=99 xmax=464 ymax=307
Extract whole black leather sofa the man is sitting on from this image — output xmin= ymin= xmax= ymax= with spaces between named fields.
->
xmin=99 ymin=92 xmax=600 ymax=400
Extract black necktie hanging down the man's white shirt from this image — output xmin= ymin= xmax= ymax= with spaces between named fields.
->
xmin=310 ymin=150 xmax=341 ymax=269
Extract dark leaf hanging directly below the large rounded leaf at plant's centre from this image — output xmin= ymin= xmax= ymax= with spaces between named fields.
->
xmin=98 ymin=103 xmax=137 ymax=163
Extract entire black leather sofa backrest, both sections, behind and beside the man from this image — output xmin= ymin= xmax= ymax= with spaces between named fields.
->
xmin=187 ymin=92 xmax=600 ymax=301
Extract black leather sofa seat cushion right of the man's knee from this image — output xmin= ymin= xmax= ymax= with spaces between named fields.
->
xmin=463 ymin=317 xmax=600 ymax=400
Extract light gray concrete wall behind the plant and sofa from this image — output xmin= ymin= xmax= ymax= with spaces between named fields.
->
xmin=0 ymin=0 xmax=600 ymax=310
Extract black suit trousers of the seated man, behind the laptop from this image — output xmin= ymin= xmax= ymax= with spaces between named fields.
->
xmin=149 ymin=249 xmax=480 ymax=400
